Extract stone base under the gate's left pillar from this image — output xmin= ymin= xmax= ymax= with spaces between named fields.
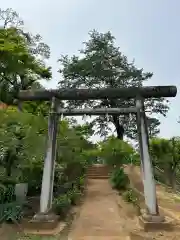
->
xmin=23 ymin=213 xmax=59 ymax=231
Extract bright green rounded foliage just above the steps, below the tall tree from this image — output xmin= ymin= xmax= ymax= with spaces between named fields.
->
xmin=100 ymin=137 xmax=135 ymax=166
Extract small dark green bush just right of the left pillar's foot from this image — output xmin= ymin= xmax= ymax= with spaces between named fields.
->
xmin=53 ymin=194 xmax=71 ymax=218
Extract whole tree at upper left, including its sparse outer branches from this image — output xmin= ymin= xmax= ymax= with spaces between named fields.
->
xmin=0 ymin=9 xmax=51 ymax=104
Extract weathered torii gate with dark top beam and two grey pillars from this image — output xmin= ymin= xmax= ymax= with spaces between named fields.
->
xmin=18 ymin=86 xmax=177 ymax=224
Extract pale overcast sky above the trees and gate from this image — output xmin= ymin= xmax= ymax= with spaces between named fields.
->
xmin=0 ymin=0 xmax=180 ymax=141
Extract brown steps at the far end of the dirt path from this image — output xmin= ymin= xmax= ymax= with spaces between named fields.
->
xmin=87 ymin=164 xmax=110 ymax=179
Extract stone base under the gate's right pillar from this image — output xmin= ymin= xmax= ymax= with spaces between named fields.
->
xmin=139 ymin=211 xmax=173 ymax=232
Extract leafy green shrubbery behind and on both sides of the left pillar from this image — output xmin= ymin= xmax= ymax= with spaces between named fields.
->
xmin=0 ymin=109 xmax=93 ymax=201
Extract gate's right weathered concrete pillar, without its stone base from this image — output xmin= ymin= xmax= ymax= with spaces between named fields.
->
xmin=136 ymin=99 xmax=159 ymax=216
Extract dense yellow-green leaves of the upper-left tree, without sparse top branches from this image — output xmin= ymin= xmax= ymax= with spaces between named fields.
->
xmin=0 ymin=27 xmax=48 ymax=75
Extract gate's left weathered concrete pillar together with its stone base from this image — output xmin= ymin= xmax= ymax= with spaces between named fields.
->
xmin=26 ymin=97 xmax=59 ymax=229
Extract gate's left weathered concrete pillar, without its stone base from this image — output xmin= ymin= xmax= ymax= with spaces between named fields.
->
xmin=40 ymin=98 xmax=58 ymax=213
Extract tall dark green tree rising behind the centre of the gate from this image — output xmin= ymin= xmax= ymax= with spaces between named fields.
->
xmin=59 ymin=30 xmax=168 ymax=139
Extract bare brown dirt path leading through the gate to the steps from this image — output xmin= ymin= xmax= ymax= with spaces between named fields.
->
xmin=68 ymin=180 xmax=129 ymax=240
